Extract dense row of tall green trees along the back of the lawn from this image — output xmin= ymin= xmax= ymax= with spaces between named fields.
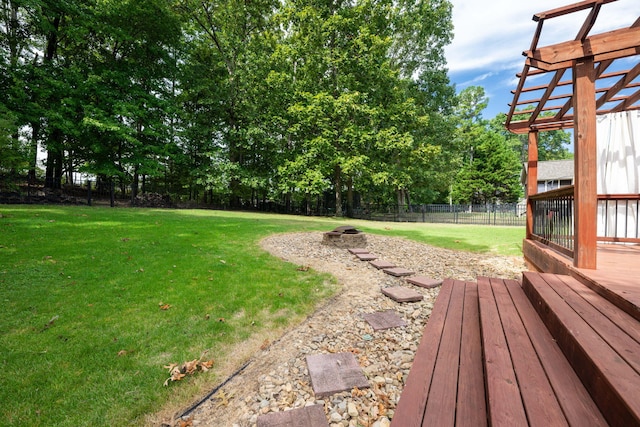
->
xmin=0 ymin=0 xmax=564 ymax=211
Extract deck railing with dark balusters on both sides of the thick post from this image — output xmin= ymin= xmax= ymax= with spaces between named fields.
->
xmin=529 ymin=186 xmax=640 ymax=257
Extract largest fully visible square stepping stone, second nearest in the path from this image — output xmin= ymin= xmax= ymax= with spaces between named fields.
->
xmin=307 ymin=353 xmax=370 ymax=397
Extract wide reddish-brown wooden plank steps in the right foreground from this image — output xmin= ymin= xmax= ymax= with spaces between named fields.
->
xmin=392 ymin=272 xmax=640 ymax=427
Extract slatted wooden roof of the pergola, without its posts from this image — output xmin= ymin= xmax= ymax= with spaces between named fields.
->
xmin=505 ymin=0 xmax=640 ymax=134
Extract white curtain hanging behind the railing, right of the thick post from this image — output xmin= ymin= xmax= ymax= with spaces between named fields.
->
xmin=596 ymin=110 xmax=640 ymax=241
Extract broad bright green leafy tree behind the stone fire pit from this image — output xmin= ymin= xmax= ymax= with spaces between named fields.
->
xmin=280 ymin=0 xmax=451 ymax=215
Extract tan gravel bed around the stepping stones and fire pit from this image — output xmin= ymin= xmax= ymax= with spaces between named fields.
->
xmin=175 ymin=233 xmax=525 ymax=427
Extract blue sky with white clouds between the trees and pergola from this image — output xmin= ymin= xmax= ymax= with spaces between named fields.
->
xmin=445 ymin=0 xmax=640 ymax=119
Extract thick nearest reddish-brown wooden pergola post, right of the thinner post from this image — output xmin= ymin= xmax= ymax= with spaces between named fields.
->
xmin=573 ymin=57 xmax=598 ymax=270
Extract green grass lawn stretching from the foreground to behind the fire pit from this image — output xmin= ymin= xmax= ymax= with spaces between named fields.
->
xmin=0 ymin=206 xmax=524 ymax=426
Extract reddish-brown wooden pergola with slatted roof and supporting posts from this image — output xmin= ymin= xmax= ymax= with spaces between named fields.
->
xmin=505 ymin=0 xmax=640 ymax=269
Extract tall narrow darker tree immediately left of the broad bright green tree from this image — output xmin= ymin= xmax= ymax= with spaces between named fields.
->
xmin=179 ymin=0 xmax=276 ymax=207
